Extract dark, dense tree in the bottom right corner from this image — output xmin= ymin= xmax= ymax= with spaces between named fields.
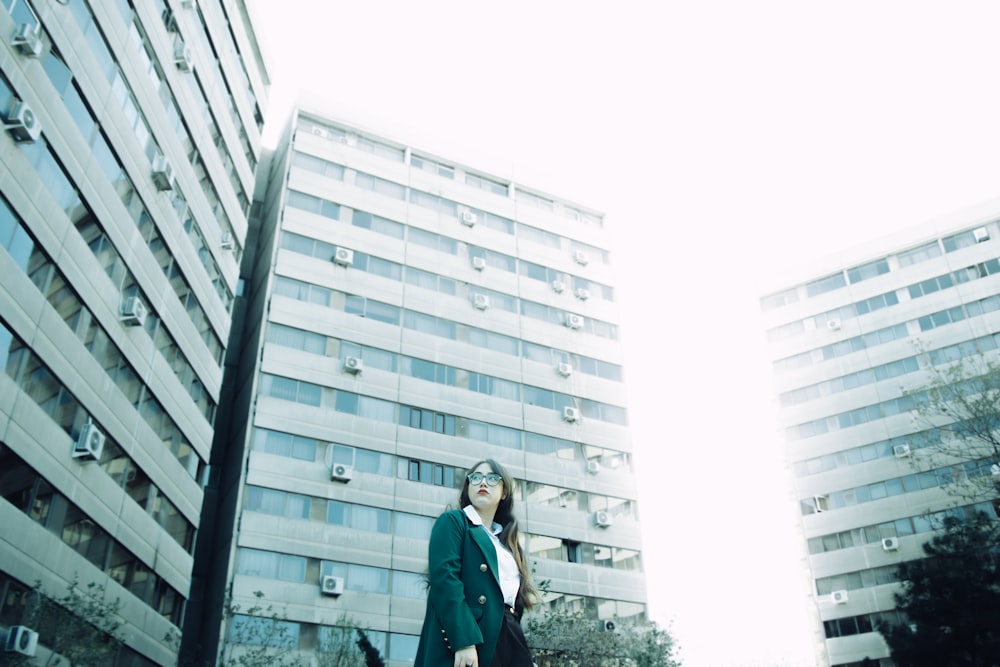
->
xmin=879 ymin=513 xmax=1000 ymax=667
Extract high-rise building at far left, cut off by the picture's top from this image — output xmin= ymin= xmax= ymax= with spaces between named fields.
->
xmin=0 ymin=0 xmax=267 ymax=665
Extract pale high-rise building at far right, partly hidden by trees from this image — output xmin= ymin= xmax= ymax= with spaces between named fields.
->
xmin=761 ymin=200 xmax=1000 ymax=667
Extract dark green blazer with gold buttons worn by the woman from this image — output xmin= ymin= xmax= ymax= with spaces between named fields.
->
xmin=413 ymin=510 xmax=504 ymax=667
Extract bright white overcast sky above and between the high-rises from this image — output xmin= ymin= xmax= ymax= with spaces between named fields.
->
xmin=247 ymin=0 xmax=1000 ymax=667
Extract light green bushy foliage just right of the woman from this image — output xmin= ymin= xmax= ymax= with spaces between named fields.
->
xmin=524 ymin=610 xmax=680 ymax=667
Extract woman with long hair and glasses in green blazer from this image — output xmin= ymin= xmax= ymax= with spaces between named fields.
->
xmin=414 ymin=459 xmax=537 ymax=667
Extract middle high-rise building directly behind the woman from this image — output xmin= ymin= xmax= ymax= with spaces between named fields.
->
xmin=195 ymin=104 xmax=646 ymax=667
